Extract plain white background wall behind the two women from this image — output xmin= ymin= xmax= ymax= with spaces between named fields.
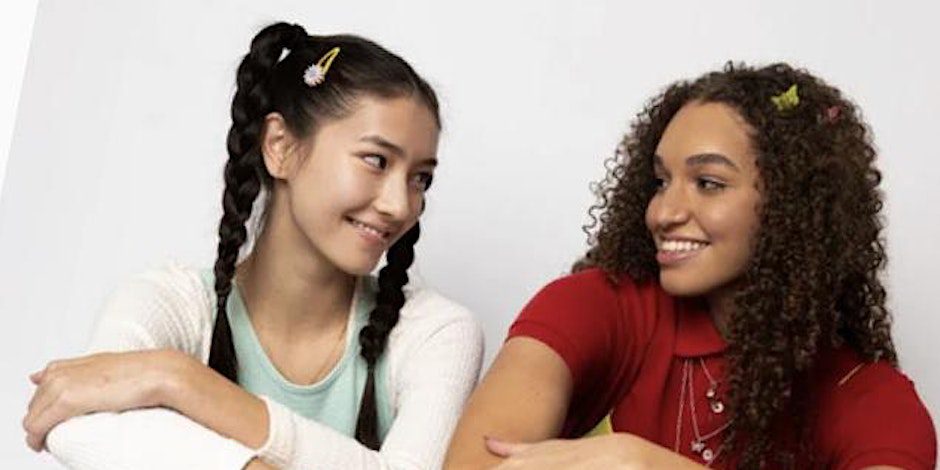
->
xmin=0 ymin=0 xmax=940 ymax=468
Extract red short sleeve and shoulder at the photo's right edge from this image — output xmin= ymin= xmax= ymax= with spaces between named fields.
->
xmin=816 ymin=347 xmax=936 ymax=468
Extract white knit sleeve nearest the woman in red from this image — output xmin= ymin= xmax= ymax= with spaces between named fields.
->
xmin=252 ymin=297 xmax=483 ymax=470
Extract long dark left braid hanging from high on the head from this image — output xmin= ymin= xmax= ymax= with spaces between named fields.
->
xmin=209 ymin=23 xmax=307 ymax=382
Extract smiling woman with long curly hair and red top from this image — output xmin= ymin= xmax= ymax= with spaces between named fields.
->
xmin=445 ymin=64 xmax=936 ymax=470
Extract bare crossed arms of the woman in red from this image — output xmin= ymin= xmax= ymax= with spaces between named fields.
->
xmin=444 ymin=337 xmax=901 ymax=470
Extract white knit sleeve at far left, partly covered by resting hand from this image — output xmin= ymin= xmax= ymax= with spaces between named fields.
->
xmin=46 ymin=266 xmax=254 ymax=470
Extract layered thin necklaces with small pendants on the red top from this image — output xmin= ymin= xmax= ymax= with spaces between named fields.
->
xmin=673 ymin=358 xmax=732 ymax=467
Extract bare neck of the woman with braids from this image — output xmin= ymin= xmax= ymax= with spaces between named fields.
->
xmin=236 ymin=198 xmax=356 ymax=336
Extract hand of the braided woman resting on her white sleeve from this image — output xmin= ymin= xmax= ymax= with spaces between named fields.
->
xmin=23 ymin=351 xmax=183 ymax=452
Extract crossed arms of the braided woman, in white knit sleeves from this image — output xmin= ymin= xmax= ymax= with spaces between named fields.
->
xmin=24 ymin=268 xmax=482 ymax=470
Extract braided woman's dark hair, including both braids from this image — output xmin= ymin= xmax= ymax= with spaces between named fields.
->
xmin=209 ymin=23 xmax=441 ymax=449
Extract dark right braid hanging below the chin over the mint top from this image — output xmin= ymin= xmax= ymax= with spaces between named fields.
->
xmin=356 ymin=223 xmax=421 ymax=450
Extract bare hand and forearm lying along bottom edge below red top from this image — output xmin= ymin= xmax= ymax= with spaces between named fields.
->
xmin=486 ymin=433 xmax=705 ymax=470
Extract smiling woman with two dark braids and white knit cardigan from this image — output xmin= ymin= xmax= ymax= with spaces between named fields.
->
xmin=24 ymin=23 xmax=482 ymax=469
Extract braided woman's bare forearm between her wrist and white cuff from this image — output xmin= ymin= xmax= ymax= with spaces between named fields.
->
xmin=159 ymin=352 xmax=269 ymax=449
